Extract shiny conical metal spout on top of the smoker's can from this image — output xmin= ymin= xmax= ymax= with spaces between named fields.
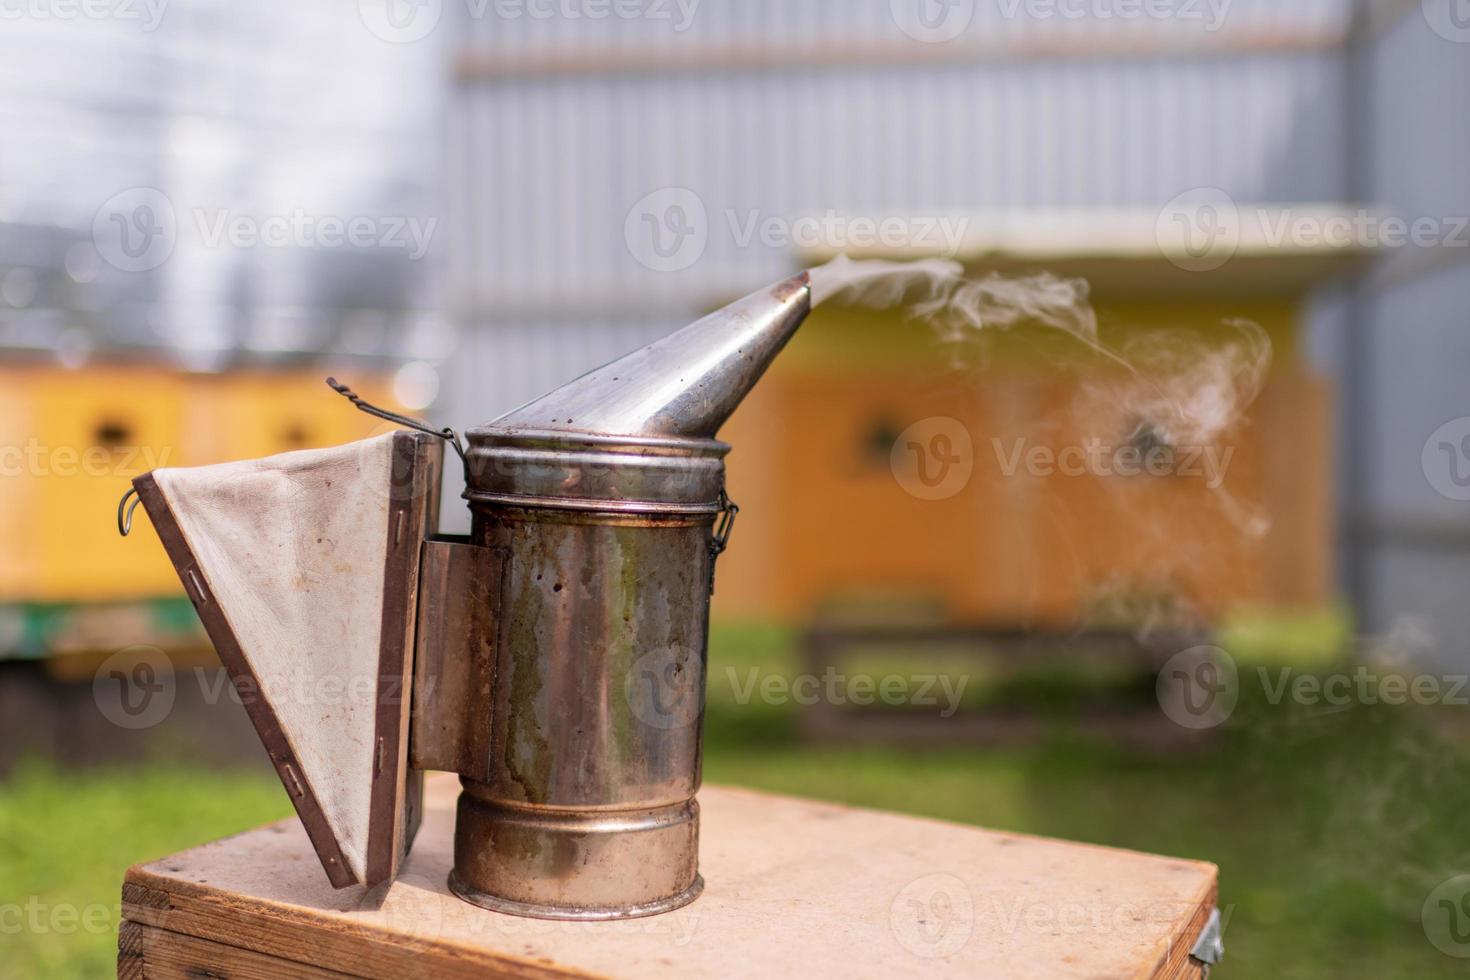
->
xmin=490 ymin=272 xmax=811 ymax=439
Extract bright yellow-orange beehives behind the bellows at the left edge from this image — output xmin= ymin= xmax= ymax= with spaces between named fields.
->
xmin=0 ymin=366 xmax=391 ymax=604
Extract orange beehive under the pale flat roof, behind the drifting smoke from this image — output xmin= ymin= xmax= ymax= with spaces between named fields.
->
xmin=716 ymin=298 xmax=1333 ymax=629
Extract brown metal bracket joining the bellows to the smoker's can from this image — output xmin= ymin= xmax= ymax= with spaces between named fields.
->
xmin=409 ymin=535 xmax=509 ymax=780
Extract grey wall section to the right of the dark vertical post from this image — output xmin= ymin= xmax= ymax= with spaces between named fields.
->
xmin=1344 ymin=0 xmax=1470 ymax=670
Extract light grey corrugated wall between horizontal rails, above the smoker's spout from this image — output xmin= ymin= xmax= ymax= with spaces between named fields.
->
xmin=453 ymin=54 xmax=1341 ymax=309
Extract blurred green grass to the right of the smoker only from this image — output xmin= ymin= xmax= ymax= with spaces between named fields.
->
xmin=706 ymin=627 xmax=1470 ymax=980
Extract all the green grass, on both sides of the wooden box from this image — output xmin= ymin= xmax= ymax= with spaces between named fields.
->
xmin=0 ymin=629 xmax=1470 ymax=980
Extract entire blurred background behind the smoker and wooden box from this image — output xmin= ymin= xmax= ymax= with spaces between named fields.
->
xmin=0 ymin=0 xmax=1470 ymax=977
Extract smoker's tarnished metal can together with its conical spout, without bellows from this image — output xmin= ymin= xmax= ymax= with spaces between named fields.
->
xmin=446 ymin=273 xmax=811 ymax=918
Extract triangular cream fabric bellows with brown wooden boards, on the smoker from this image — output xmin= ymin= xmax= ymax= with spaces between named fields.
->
xmin=134 ymin=432 xmax=442 ymax=887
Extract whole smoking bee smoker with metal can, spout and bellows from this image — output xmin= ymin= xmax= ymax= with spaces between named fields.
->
xmin=119 ymin=273 xmax=811 ymax=918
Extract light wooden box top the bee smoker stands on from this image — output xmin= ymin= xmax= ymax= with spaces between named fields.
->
xmin=118 ymin=776 xmax=1217 ymax=980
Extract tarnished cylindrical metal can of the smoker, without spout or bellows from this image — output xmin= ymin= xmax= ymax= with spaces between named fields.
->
xmin=451 ymin=428 xmax=728 ymax=918
